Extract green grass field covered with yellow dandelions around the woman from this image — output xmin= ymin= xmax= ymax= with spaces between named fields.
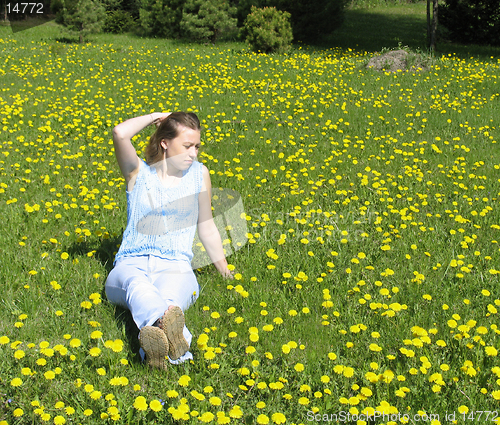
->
xmin=0 ymin=19 xmax=500 ymax=424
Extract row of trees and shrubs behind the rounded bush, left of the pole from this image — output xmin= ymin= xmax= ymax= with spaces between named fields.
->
xmin=38 ymin=0 xmax=347 ymax=42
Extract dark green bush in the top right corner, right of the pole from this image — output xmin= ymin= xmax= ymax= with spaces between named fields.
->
xmin=439 ymin=0 xmax=500 ymax=46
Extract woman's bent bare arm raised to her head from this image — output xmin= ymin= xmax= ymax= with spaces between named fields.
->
xmin=113 ymin=112 xmax=170 ymax=184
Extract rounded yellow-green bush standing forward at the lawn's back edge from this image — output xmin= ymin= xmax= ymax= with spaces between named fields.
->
xmin=244 ymin=6 xmax=293 ymax=53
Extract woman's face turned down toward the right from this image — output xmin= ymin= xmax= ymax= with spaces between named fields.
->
xmin=161 ymin=126 xmax=201 ymax=171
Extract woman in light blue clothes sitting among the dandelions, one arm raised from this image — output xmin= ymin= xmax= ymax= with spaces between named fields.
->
xmin=106 ymin=112 xmax=232 ymax=369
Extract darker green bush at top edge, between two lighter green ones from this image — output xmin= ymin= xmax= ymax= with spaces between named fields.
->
xmin=139 ymin=0 xmax=185 ymax=38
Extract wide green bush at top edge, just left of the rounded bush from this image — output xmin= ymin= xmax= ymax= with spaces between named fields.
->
xmin=180 ymin=0 xmax=237 ymax=42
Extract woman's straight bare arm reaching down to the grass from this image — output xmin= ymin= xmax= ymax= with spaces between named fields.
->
xmin=198 ymin=166 xmax=233 ymax=278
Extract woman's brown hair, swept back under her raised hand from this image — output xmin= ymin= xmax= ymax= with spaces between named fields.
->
xmin=145 ymin=112 xmax=201 ymax=165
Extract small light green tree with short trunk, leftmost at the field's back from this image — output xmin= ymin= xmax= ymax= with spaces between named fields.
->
xmin=54 ymin=0 xmax=106 ymax=43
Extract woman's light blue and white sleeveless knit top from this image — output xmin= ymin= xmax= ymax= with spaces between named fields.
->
xmin=113 ymin=160 xmax=203 ymax=266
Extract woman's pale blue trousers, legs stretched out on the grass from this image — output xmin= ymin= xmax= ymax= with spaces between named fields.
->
xmin=106 ymin=255 xmax=200 ymax=364
